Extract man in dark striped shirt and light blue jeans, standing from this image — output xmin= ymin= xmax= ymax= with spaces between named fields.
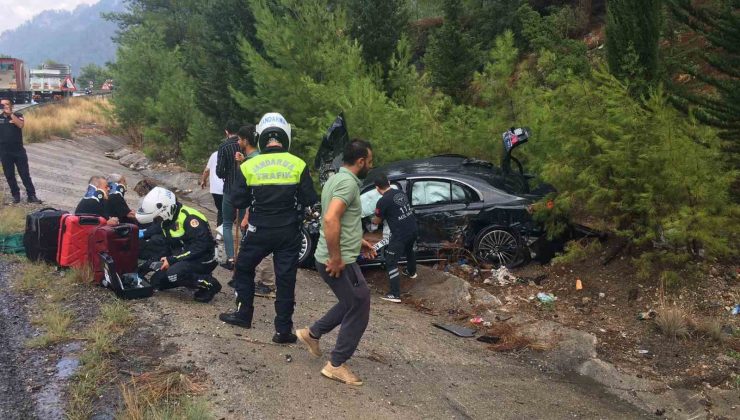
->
xmin=216 ymin=120 xmax=246 ymax=270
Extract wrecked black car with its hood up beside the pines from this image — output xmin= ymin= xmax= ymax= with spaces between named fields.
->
xmin=301 ymin=115 xmax=587 ymax=267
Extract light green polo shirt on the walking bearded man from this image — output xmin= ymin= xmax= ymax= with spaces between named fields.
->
xmin=314 ymin=167 xmax=362 ymax=264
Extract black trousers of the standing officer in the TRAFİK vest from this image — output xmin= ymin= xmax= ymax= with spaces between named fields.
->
xmin=234 ymin=223 xmax=301 ymax=333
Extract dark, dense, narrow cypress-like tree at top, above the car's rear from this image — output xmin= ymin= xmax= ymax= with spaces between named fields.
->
xmin=424 ymin=0 xmax=481 ymax=101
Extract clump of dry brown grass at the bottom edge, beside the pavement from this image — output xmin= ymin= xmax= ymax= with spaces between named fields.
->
xmin=118 ymin=368 xmax=212 ymax=420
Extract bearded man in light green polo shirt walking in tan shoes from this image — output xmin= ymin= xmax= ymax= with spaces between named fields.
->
xmin=296 ymin=139 xmax=375 ymax=385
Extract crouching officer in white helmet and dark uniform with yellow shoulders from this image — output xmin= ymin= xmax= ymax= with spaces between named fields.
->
xmin=136 ymin=187 xmax=221 ymax=303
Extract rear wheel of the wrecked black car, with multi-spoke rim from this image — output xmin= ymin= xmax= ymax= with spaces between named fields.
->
xmin=474 ymin=227 xmax=527 ymax=268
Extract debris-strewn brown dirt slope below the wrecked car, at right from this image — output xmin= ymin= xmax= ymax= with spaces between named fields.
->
xmin=448 ymin=240 xmax=740 ymax=389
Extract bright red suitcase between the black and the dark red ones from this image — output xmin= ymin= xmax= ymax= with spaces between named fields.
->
xmin=57 ymin=214 xmax=105 ymax=268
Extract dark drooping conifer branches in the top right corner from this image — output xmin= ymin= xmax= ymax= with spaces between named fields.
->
xmin=668 ymin=0 xmax=740 ymax=144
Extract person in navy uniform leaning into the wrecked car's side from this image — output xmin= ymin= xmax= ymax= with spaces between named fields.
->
xmin=373 ymin=175 xmax=418 ymax=303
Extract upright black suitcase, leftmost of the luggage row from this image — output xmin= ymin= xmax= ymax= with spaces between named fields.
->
xmin=23 ymin=207 xmax=69 ymax=264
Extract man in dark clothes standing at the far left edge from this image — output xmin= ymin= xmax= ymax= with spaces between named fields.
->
xmin=0 ymin=99 xmax=41 ymax=204
